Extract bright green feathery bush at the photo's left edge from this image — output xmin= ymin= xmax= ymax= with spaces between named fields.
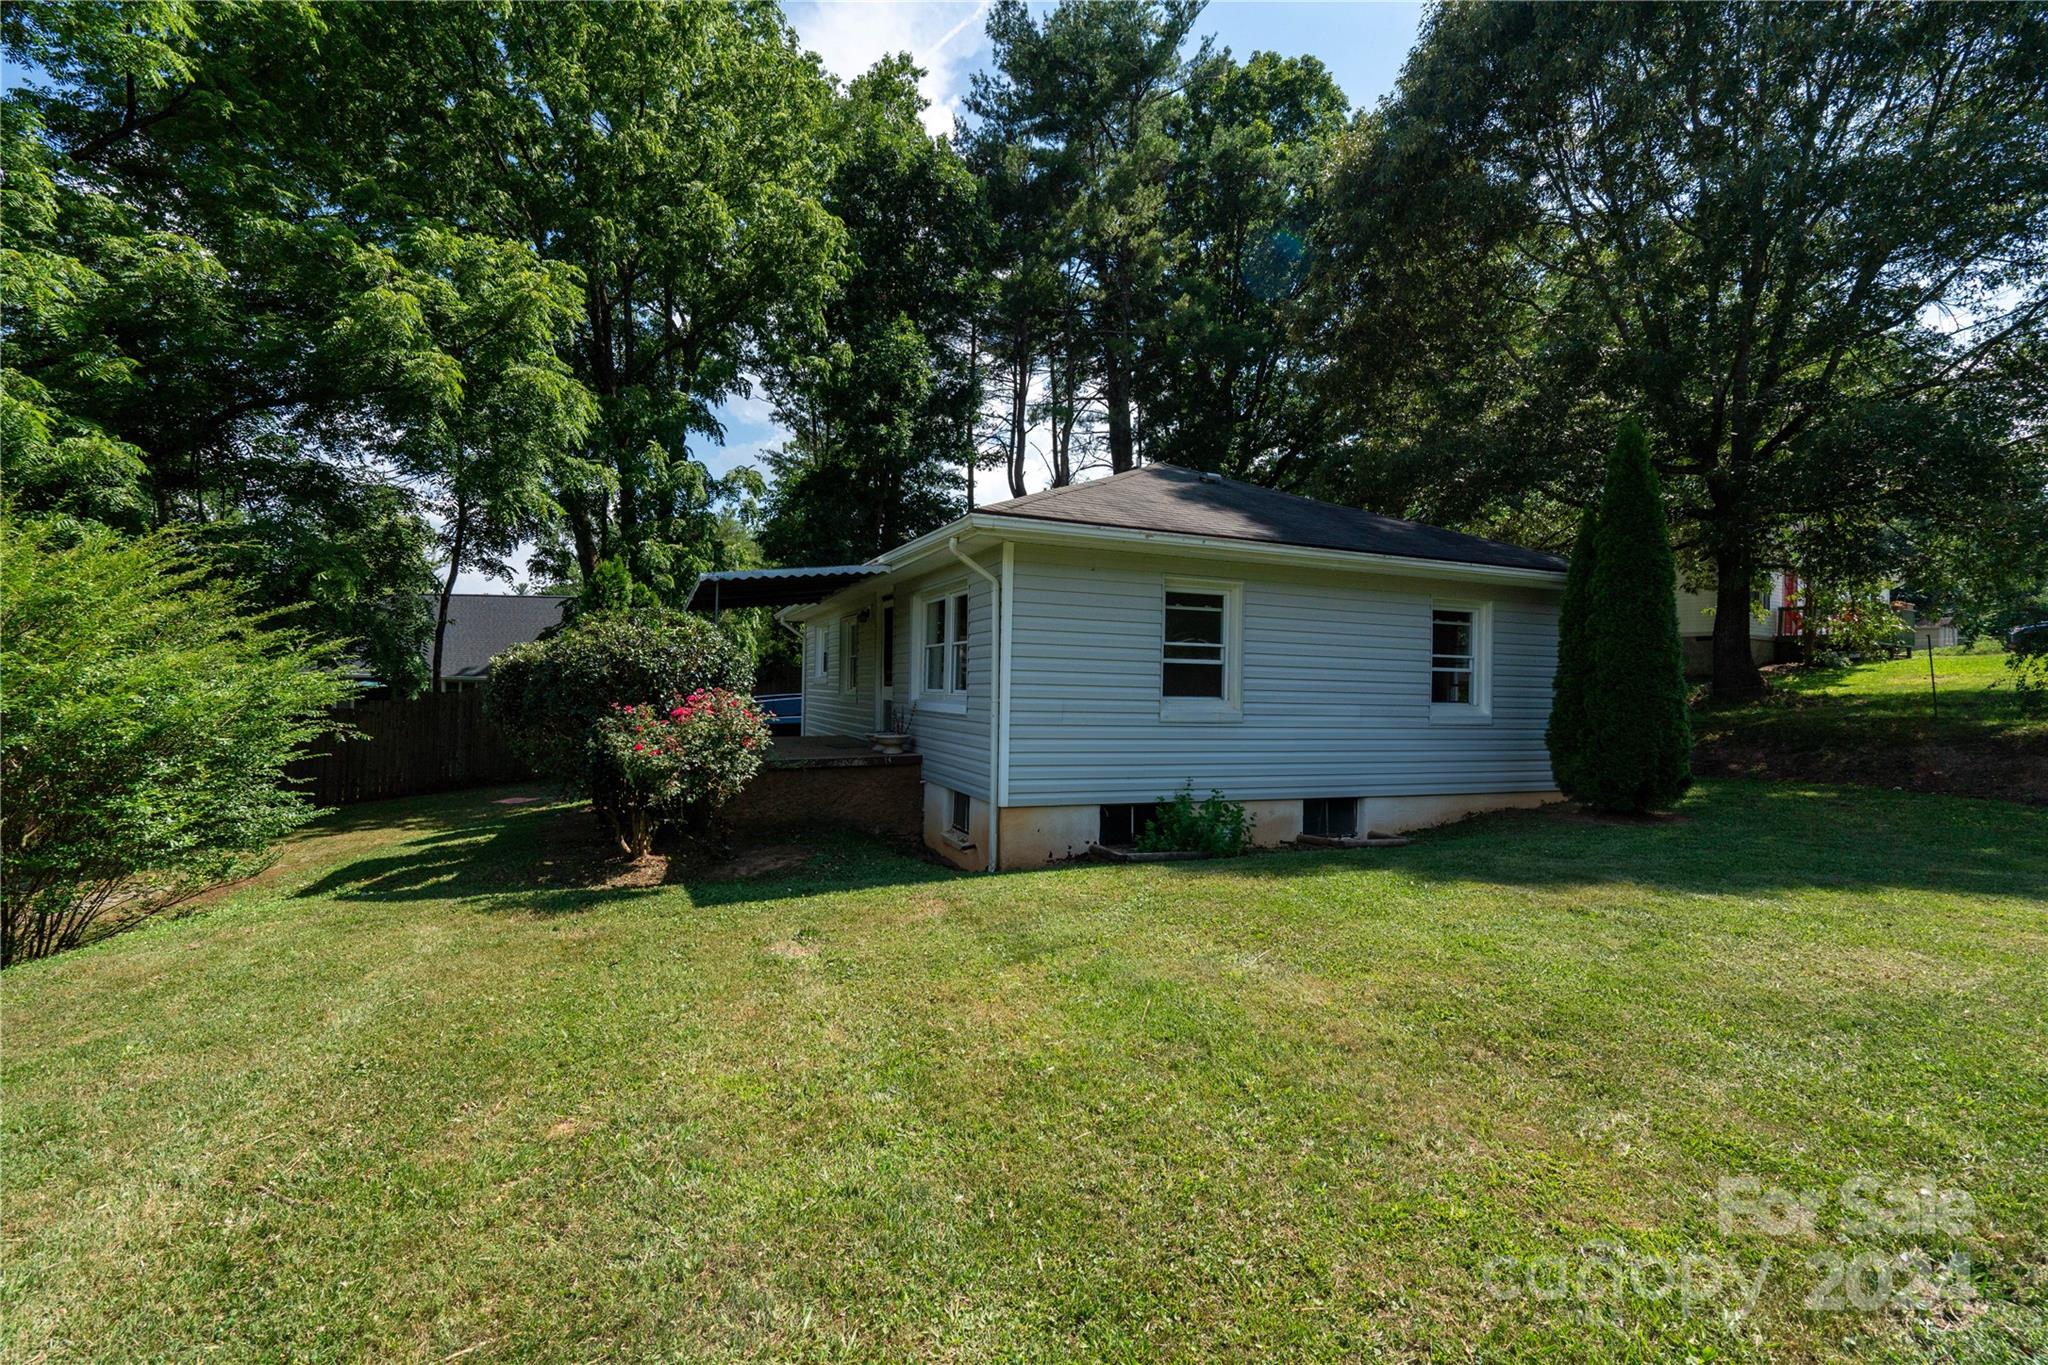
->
xmin=0 ymin=520 xmax=348 ymax=966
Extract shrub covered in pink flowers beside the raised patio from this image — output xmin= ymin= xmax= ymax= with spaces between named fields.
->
xmin=590 ymin=688 xmax=770 ymax=855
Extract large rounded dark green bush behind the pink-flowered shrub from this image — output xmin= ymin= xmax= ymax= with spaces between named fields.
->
xmin=483 ymin=612 xmax=754 ymax=843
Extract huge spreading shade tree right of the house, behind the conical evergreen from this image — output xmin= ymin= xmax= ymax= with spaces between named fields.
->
xmin=1309 ymin=4 xmax=2048 ymax=696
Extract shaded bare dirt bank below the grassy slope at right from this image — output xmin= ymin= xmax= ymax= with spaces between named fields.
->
xmin=1692 ymin=739 xmax=2048 ymax=806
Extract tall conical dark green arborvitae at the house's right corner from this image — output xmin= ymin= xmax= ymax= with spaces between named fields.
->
xmin=1571 ymin=417 xmax=1692 ymax=810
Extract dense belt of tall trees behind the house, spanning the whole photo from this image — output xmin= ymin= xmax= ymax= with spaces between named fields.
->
xmin=0 ymin=0 xmax=2048 ymax=720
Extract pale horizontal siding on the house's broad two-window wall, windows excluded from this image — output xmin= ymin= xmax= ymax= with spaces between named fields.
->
xmin=999 ymin=546 xmax=1559 ymax=806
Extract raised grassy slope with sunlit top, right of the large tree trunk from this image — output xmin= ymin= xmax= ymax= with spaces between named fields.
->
xmin=1694 ymin=649 xmax=2048 ymax=802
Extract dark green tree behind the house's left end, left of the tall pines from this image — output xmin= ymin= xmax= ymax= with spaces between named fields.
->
xmin=762 ymin=57 xmax=987 ymax=563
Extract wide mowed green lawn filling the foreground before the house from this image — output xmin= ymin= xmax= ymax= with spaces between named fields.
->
xmin=0 ymin=782 xmax=2048 ymax=1363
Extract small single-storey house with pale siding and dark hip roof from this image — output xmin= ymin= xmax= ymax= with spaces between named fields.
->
xmin=698 ymin=465 xmax=1565 ymax=868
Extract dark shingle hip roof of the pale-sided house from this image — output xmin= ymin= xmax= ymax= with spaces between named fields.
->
xmin=975 ymin=465 xmax=1565 ymax=573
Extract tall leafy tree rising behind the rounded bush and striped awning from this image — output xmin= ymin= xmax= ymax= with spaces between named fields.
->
xmin=366 ymin=2 xmax=844 ymax=600
